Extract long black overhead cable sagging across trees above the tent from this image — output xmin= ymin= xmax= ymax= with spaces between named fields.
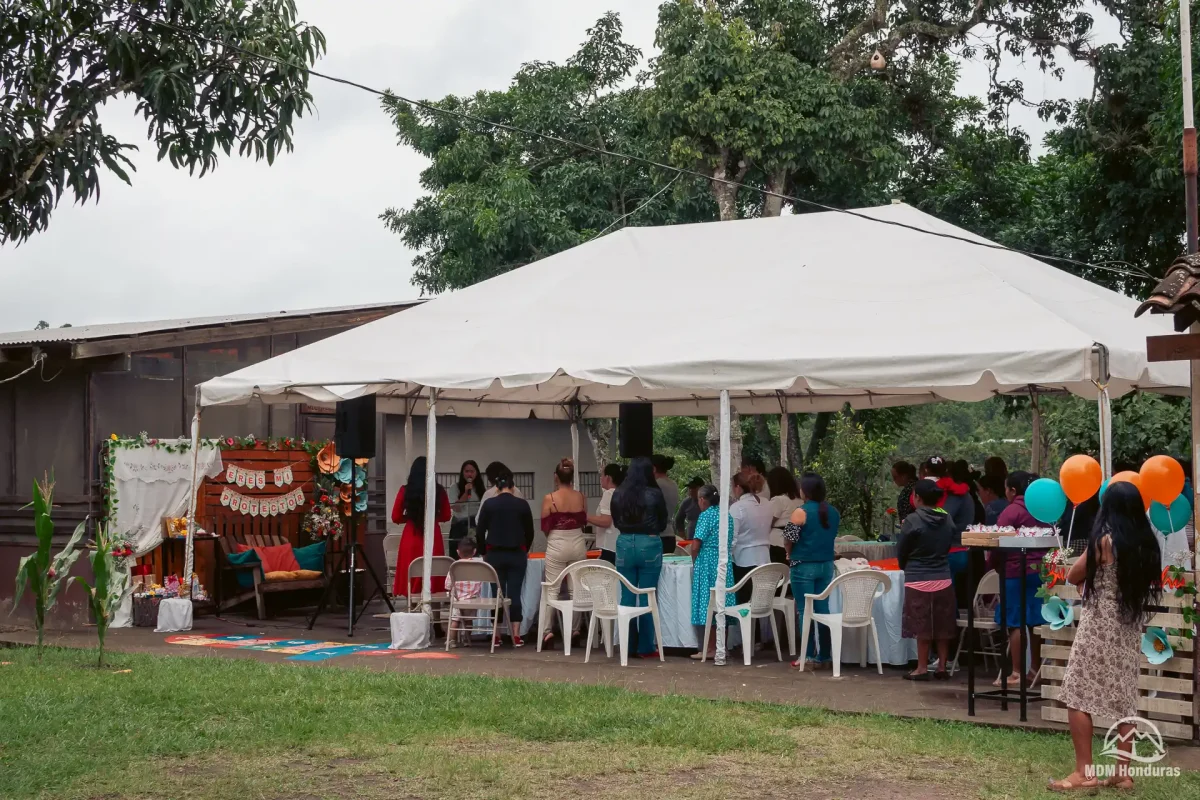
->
xmin=139 ymin=18 xmax=1158 ymax=281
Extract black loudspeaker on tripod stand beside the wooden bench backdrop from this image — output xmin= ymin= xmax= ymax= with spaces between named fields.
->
xmin=308 ymin=395 xmax=396 ymax=637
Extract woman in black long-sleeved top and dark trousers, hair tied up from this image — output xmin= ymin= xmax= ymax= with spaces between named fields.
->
xmin=475 ymin=470 xmax=533 ymax=648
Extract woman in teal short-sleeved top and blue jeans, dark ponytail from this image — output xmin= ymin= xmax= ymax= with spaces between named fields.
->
xmin=784 ymin=473 xmax=841 ymax=669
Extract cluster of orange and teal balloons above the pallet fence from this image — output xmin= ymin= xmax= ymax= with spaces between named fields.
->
xmin=1025 ymin=455 xmax=1192 ymax=534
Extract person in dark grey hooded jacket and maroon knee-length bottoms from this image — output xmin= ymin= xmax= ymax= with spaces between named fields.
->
xmin=898 ymin=480 xmax=959 ymax=680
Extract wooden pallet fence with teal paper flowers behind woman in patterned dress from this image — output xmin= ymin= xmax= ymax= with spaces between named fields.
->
xmin=1037 ymin=575 xmax=1200 ymax=740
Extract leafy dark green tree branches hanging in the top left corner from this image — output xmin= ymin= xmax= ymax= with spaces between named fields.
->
xmin=0 ymin=0 xmax=325 ymax=242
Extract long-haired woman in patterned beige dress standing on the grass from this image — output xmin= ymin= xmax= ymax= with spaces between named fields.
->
xmin=1049 ymin=483 xmax=1163 ymax=792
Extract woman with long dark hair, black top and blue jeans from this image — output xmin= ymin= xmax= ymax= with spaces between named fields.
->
xmin=610 ymin=458 xmax=670 ymax=658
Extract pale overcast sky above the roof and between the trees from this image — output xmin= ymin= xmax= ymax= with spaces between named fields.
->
xmin=0 ymin=0 xmax=1116 ymax=331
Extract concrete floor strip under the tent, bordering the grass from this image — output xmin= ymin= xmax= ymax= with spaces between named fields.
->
xmin=7 ymin=603 xmax=1200 ymax=769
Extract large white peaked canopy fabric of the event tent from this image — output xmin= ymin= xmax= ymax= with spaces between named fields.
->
xmin=200 ymin=204 xmax=1188 ymax=420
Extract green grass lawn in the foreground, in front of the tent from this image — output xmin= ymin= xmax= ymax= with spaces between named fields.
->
xmin=0 ymin=648 xmax=1200 ymax=800
